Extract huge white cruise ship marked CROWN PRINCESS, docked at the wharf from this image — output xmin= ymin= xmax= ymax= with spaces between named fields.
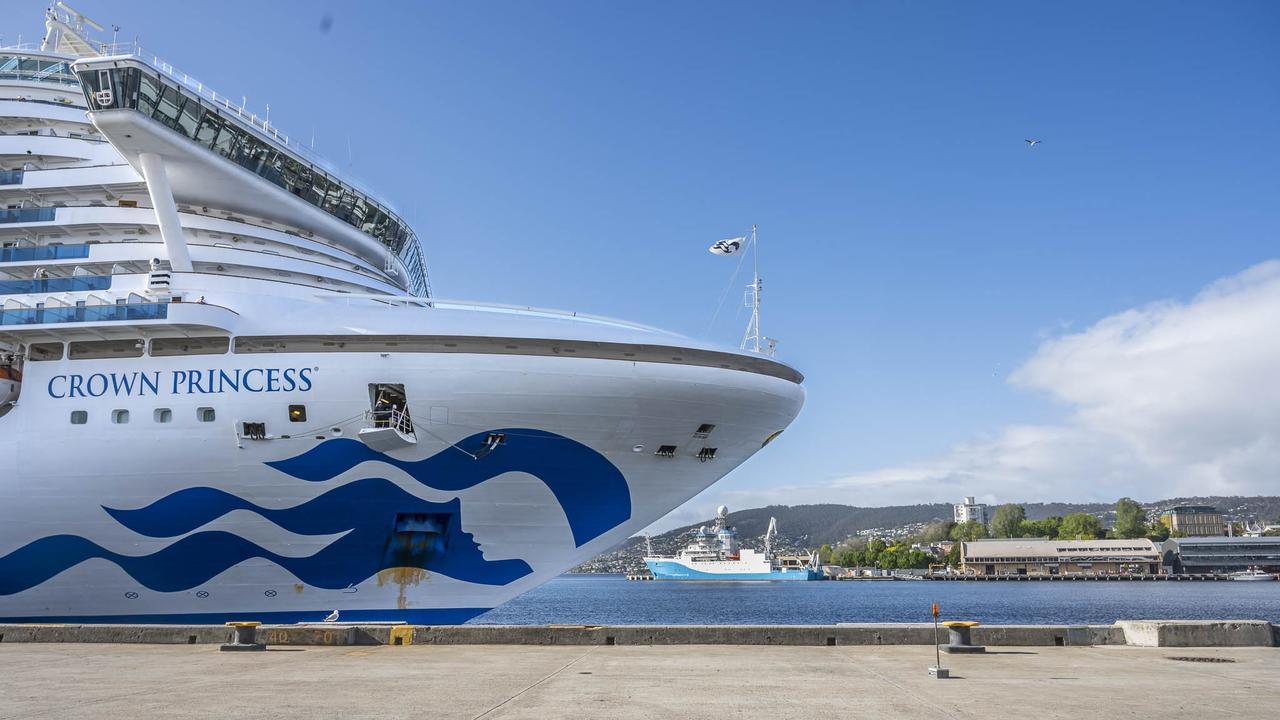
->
xmin=0 ymin=3 xmax=804 ymax=624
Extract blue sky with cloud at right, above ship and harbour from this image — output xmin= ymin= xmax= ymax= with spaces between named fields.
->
xmin=15 ymin=0 xmax=1280 ymax=521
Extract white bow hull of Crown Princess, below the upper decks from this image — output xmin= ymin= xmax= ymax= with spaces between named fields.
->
xmin=0 ymin=333 xmax=800 ymax=623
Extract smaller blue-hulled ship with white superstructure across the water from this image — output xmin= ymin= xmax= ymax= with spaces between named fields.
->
xmin=644 ymin=505 xmax=823 ymax=580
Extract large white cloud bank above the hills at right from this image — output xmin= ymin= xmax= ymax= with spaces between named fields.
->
xmin=663 ymin=261 xmax=1280 ymax=527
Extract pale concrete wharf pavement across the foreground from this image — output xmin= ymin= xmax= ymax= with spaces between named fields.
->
xmin=0 ymin=643 xmax=1280 ymax=720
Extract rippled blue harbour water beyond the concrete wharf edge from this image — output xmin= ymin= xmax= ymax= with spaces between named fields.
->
xmin=472 ymin=575 xmax=1280 ymax=625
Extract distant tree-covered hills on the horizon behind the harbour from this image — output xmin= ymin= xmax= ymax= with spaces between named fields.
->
xmin=576 ymin=496 xmax=1280 ymax=573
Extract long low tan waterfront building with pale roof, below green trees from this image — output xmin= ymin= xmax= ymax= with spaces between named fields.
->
xmin=960 ymin=538 xmax=1161 ymax=575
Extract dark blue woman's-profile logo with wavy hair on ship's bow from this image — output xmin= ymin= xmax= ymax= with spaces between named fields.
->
xmin=0 ymin=428 xmax=631 ymax=596
